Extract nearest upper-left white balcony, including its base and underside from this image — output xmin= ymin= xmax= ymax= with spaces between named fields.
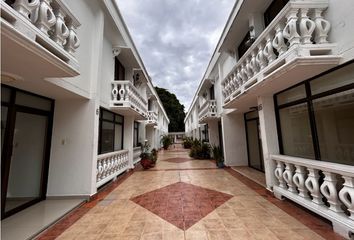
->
xmin=1 ymin=0 xmax=80 ymax=79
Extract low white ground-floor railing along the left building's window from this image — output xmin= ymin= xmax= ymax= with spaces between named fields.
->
xmin=96 ymin=150 xmax=129 ymax=187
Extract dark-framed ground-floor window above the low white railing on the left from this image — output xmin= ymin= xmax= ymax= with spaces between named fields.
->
xmin=98 ymin=108 xmax=124 ymax=154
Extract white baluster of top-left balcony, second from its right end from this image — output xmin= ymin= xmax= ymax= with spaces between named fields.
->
xmin=52 ymin=7 xmax=70 ymax=47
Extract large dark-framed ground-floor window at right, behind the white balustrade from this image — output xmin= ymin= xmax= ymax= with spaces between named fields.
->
xmin=274 ymin=63 xmax=354 ymax=165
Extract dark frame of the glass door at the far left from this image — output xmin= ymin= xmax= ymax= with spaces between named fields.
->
xmin=1 ymin=84 xmax=54 ymax=219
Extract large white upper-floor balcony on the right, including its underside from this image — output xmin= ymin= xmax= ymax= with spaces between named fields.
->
xmin=222 ymin=1 xmax=340 ymax=108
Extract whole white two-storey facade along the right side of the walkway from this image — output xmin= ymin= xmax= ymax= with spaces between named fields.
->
xmin=185 ymin=0 xmax=354 ymax=238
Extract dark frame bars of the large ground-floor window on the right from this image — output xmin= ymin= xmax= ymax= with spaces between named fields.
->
xmin=273 ymin=60 xmax=354 ymax=161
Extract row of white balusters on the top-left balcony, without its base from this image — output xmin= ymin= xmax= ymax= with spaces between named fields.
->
xmin=2 ymin=0 xmax=80 ymax=55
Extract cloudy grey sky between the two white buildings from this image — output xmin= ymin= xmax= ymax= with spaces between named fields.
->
xmin=117 ymin=0 xmax=235 ymax=111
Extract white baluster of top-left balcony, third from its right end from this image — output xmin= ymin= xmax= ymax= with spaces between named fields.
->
xmin=36 ymin=0 xmax=56 ymax=36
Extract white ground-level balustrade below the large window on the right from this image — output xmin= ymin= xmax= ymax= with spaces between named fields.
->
xmin=271 ymin=155 xmax=354 ymax=237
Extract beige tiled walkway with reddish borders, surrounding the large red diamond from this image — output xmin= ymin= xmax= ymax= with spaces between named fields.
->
xmin=35 ymin=147 xmax=343 ymax=240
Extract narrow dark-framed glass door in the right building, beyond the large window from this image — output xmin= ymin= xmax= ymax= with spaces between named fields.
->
xmin=245 ymin=111 xmax=264 ymax=172
